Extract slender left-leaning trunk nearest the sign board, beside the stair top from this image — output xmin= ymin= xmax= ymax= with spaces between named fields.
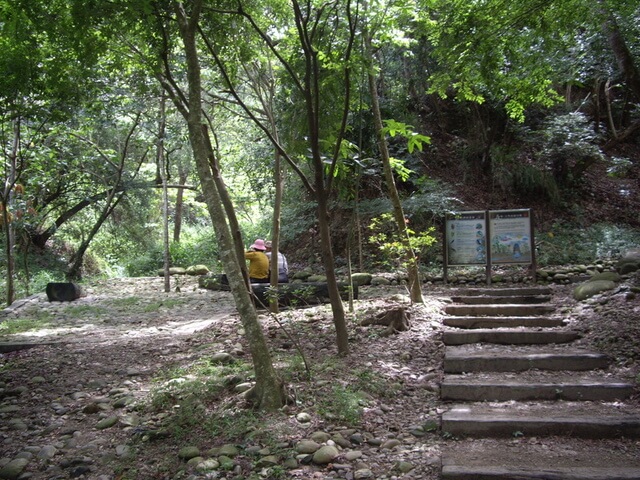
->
xmin=364 ymin=32 xmax=424 ymax=303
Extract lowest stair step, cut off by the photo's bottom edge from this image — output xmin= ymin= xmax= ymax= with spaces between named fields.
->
xmin=441 ymin=437 xmax=640 ymax=480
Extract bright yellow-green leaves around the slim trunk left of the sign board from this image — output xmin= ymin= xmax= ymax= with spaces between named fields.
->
xmin=368 ymin=213 xmax=437 ymax=268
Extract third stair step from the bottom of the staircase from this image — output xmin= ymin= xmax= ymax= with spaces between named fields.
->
xmin=440 ymin=372 xmax=634 ymax=402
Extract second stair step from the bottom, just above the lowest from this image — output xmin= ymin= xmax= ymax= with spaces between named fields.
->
xmin=441 ymin=402 xmax=640 ymax=438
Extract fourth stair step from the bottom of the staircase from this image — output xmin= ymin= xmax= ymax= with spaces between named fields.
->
xmin=444 ymin=345 xmax=609 ymax=373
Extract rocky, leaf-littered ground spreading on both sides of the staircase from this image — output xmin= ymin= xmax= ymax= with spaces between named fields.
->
xmin=0 ymin=277 xmax=640 ymax=480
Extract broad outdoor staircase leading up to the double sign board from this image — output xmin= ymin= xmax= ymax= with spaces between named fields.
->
xmin=440 ymin=287 xmax=640 ymax=480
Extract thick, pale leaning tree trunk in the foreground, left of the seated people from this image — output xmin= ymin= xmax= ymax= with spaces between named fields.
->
xmin=172 ymin=0 xmax=285 ymax=410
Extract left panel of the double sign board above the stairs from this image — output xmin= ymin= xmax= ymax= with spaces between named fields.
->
xmin=446 ymin=212 xmax=487 ymax=265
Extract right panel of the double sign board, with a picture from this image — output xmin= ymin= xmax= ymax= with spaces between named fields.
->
xmin=489 ymin=210 xmax=532 ymax=263
